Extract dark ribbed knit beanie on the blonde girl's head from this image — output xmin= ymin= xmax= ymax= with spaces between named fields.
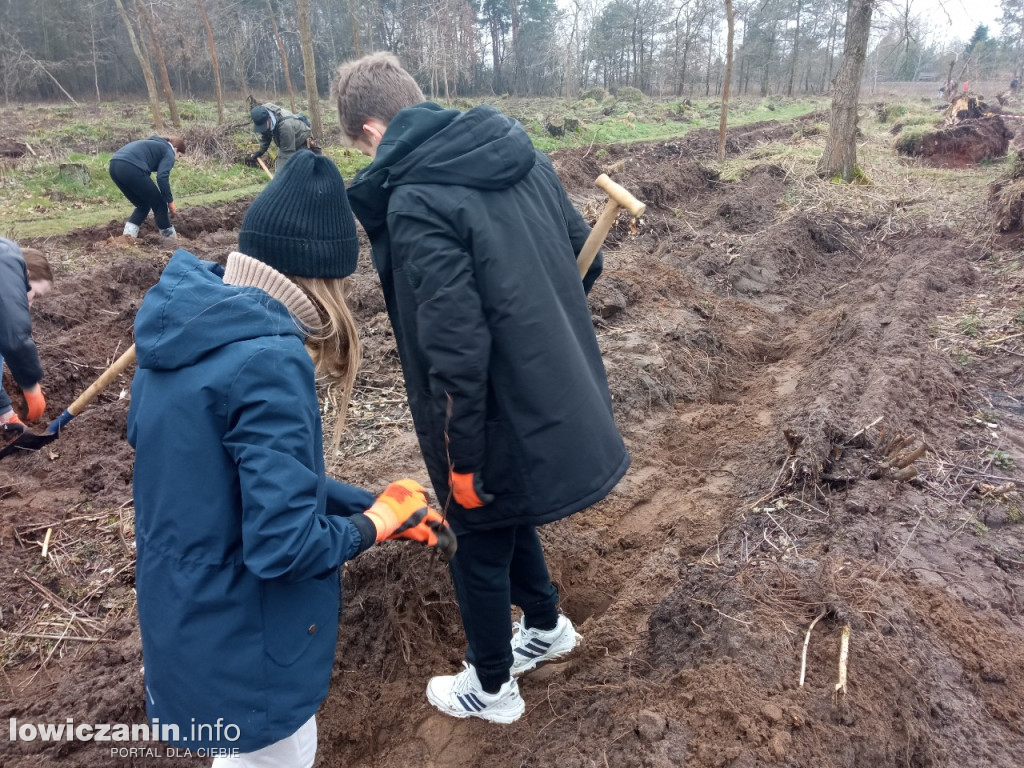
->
xmin=239 ymin=150 xmax=359 ymax=278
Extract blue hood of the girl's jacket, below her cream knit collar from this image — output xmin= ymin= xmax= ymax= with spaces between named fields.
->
xmin=135 ymin=250 xmax=304 ymax=371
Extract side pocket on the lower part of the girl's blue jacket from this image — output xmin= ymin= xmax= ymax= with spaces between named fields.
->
xmin=262 ymin=570 xmax=338 ymax=667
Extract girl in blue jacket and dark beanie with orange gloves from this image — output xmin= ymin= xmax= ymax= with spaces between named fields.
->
xmin=128 ymin=152 xmax=454 ymax=768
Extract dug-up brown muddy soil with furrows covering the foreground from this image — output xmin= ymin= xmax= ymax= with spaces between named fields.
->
xmin=0 ymin=115 xmax=1024 ymax=768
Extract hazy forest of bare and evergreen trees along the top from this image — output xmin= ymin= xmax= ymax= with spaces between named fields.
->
xmin=0 ymin=0 xmax=1024 ymax=103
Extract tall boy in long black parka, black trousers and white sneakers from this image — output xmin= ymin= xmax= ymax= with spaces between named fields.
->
xmin=332 ymin=53 xmax=630 ymax=723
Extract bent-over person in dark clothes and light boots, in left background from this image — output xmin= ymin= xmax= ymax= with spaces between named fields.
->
xmin=111 ymin=136 xmax=185 ymax=238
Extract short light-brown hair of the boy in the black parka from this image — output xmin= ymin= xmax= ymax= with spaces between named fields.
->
xmin=331 ymin=51 xmax=427 ymax=143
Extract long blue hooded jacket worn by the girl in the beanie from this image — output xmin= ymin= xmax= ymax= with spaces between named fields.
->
xmin=128 ymin=250 xmax=375 ymax=752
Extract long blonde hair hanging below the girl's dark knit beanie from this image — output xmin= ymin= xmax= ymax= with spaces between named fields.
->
xmin=289 ymin=275 xmax=362 ymax=450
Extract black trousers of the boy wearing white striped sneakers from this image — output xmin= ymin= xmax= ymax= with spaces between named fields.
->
xmin=450 ymin=525 xmax=558 ymax=689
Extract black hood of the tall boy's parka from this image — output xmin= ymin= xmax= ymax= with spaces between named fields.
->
xmin=348 ymin=101 xmax=537 ymax=231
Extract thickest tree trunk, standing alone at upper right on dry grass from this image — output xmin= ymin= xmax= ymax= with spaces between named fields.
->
xmin=818 ymin=0 xmax=874 ymax=182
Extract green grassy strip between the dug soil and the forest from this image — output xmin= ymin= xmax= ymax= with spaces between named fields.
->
xmin=0 ymin=96 xmax=828 ymax=238
